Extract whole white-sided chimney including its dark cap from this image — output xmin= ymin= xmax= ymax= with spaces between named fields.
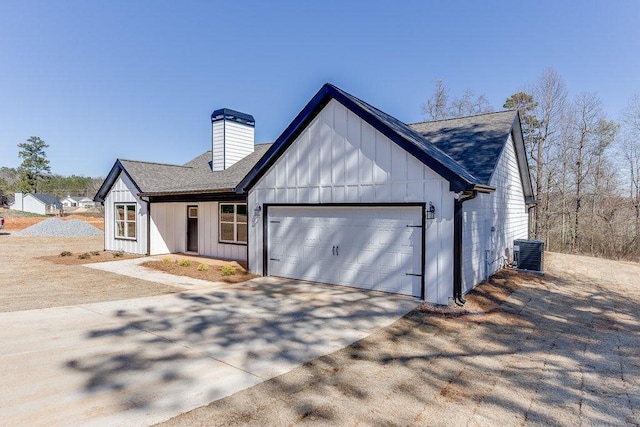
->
xmin=211 ymin=108 xmax=256 ymax=171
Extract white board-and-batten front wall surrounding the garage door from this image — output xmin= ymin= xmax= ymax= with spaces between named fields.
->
xmin=248 ymin=100 xmax=454 ymax=304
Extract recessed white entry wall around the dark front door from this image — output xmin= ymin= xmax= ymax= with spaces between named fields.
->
xmin=151 ymin=202 xmax=247 ymax=261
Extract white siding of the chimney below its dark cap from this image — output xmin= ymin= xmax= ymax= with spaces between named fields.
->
xmin=212 ymin=120 xmax=255 ymax=171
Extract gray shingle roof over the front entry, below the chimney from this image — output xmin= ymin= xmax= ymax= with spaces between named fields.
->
xmin=119 ymin=144 xmax=271 ymax=195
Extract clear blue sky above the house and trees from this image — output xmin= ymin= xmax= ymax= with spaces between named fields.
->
xmin=0 ymin=0 xmax=640 ymax=177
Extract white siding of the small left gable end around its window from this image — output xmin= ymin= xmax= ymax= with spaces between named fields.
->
xmin=104 ymin=173 xmax=147 ymax=255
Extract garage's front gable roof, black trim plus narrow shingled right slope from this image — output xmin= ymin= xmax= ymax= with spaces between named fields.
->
xmin=236 ymin=83 xmax=491 ymax=193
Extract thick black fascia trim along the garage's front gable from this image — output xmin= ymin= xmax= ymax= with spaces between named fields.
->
xmin=236 ymin=83 xmax=477 ymax=194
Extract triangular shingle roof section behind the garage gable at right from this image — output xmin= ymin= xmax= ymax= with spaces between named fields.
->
xmin=409 ymin=111 xmax=516 ymax=185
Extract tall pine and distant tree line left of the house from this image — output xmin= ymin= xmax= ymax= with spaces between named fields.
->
xmin=0 ymin=136 xmax=103 ymax=205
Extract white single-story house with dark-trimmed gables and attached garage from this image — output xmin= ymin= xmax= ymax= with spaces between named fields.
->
xmin=94 ymin=84 xmax=535 ymax=304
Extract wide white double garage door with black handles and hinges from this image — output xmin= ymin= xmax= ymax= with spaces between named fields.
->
xmin=267 ymin=206 xmax=422 ymax=297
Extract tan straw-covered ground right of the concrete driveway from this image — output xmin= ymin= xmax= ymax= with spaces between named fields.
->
xmin=159 ymin=254 xmax=640 ymax=426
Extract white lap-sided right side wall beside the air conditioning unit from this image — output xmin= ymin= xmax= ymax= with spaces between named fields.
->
xmin=462 ymin=136 xmax=529 ymax=292
